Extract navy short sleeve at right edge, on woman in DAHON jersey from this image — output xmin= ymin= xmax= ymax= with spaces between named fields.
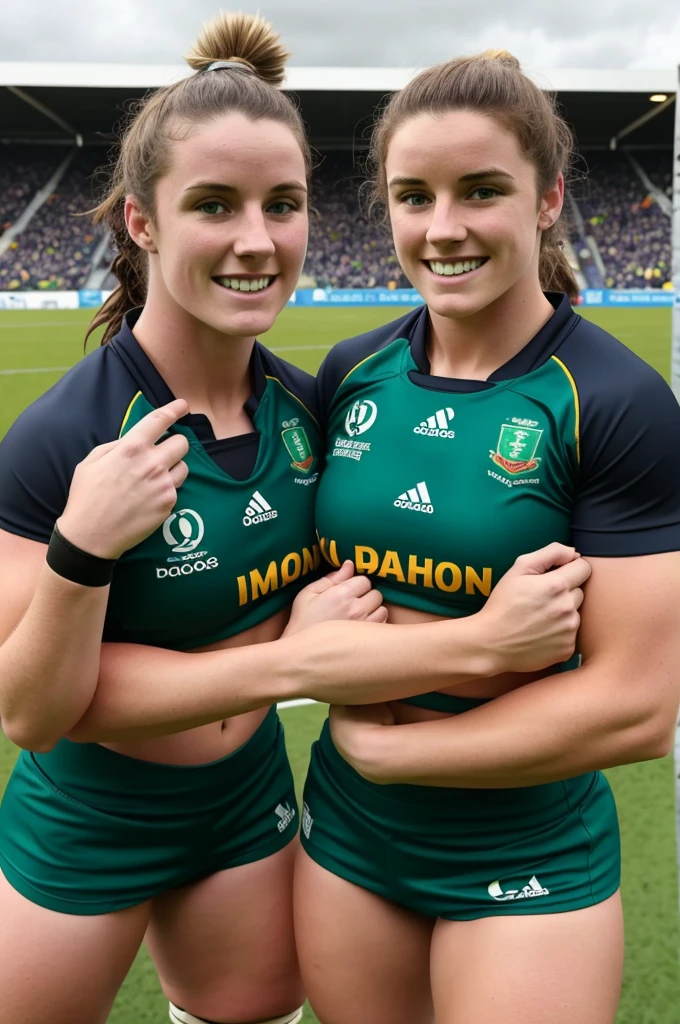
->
xmin=555 ymin=319 xmax=680 ymax=556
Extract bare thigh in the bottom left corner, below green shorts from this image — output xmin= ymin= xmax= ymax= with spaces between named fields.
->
xmin=0 ymin=873 xmax=150 ymax=1024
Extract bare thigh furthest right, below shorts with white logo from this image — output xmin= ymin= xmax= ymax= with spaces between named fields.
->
xmin=431 ymin=893 xmax=624 ymax=1024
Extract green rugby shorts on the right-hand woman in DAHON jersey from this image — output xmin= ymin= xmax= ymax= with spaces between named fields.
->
xmin=301 ymin=712 xmax=621 ymax=921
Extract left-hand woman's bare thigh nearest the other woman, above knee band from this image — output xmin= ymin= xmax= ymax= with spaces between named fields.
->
xmin=146 ymin=842 xmax=304 ymax=1021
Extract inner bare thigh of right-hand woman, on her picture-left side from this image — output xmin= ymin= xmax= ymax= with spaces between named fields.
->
xmin=295 ymin=850 xmax=433 ymax=1024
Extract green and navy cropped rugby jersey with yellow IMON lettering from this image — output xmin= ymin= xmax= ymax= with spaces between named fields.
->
xmin=0 ymin=313 xmax=321 ymax=649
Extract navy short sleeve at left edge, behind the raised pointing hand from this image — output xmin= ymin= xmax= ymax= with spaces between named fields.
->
xmin=0 ymin=345 xmax=138 ymax=544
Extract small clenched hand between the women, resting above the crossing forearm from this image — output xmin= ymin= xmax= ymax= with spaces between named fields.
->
xmin=284 ymin=561 xmax=387 ymax=636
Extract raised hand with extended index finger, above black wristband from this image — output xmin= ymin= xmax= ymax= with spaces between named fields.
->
xmin=57 ymin=398 xmax=188 ymax=558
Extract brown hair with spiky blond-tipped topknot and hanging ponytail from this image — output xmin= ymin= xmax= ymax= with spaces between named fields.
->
xmin=85 ymin=13 xmax=311 ymax=345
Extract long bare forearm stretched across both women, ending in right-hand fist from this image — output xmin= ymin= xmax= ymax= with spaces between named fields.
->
xmin=69 ymin=544 xmax=590 ymax=742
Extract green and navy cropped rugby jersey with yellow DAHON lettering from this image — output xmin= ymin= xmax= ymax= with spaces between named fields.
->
xmin=316 ymin=295 xmax=680 ymax=616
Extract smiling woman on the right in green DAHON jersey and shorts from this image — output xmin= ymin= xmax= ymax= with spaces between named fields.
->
xmin=296 ymin=51 xmax=680 ymax=1024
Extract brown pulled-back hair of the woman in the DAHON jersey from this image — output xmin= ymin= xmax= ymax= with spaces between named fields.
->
xmin=369 ymin=50 xmax=579 ymax=299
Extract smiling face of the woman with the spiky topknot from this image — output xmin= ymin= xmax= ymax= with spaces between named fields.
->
xmin=126 ymin=114 xmax=308 ymax=338
